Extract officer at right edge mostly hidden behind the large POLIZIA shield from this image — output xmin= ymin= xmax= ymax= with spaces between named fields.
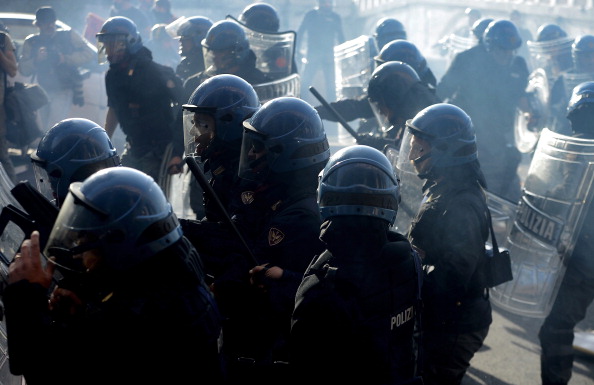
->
xmin=538 ymin=81 xmax=594 ymax=385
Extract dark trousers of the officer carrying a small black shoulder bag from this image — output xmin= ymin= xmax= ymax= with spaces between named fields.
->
xmin=423 ymin=327 xmax=489 ymax=385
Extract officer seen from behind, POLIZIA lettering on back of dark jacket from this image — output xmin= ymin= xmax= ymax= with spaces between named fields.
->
xmin=290 ymin=145 xmax=422 ymax=384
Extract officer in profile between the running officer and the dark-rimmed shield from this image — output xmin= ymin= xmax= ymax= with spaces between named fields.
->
xmin=175 ymin=16 xmax=213 ymax=80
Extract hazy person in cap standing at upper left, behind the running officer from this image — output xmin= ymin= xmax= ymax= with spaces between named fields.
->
xmin=18 ymin=7 xmax=95 ymax=132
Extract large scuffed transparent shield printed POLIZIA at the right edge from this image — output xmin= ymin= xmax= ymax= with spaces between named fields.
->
xmin=491 ymin=128 xmax=594 ymax=318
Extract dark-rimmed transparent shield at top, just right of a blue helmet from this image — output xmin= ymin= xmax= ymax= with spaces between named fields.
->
xmin=226 ymin=15 xmax=297 ymax=79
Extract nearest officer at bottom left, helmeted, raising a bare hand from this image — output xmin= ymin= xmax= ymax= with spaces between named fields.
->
xmin=3 ymin=167 xmax=223 ymax=384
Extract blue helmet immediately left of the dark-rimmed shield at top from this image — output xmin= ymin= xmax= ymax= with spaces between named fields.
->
xmin=202 ymin=19 xmax=250 ymax=72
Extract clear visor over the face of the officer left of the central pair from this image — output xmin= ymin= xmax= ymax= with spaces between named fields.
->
xmin=183 ymin=109 xmax=215 ymax=156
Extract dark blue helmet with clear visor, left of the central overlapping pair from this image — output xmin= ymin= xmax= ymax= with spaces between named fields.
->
xmin=183 ymin=74 xmax=260 ymax=157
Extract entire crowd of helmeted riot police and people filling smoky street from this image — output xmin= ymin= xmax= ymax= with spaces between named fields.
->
xmin=0 ymin=0 xmax=594 ymax=385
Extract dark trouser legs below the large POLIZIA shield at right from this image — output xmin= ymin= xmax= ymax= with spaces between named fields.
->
xmin=538 ymin=260 xmax=594 ymax=385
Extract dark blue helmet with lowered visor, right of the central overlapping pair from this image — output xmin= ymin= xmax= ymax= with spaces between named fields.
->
xmin=239 ymin=96 xmax=330 ymax=183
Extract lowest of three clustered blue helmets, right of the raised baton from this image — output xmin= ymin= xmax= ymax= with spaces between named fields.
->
xmin=367 ymin=61 xmax=421 ymax=130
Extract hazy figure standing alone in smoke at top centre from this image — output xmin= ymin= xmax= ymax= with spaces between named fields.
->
xmin=296 ymin=0 xmax=345 ymax=102
